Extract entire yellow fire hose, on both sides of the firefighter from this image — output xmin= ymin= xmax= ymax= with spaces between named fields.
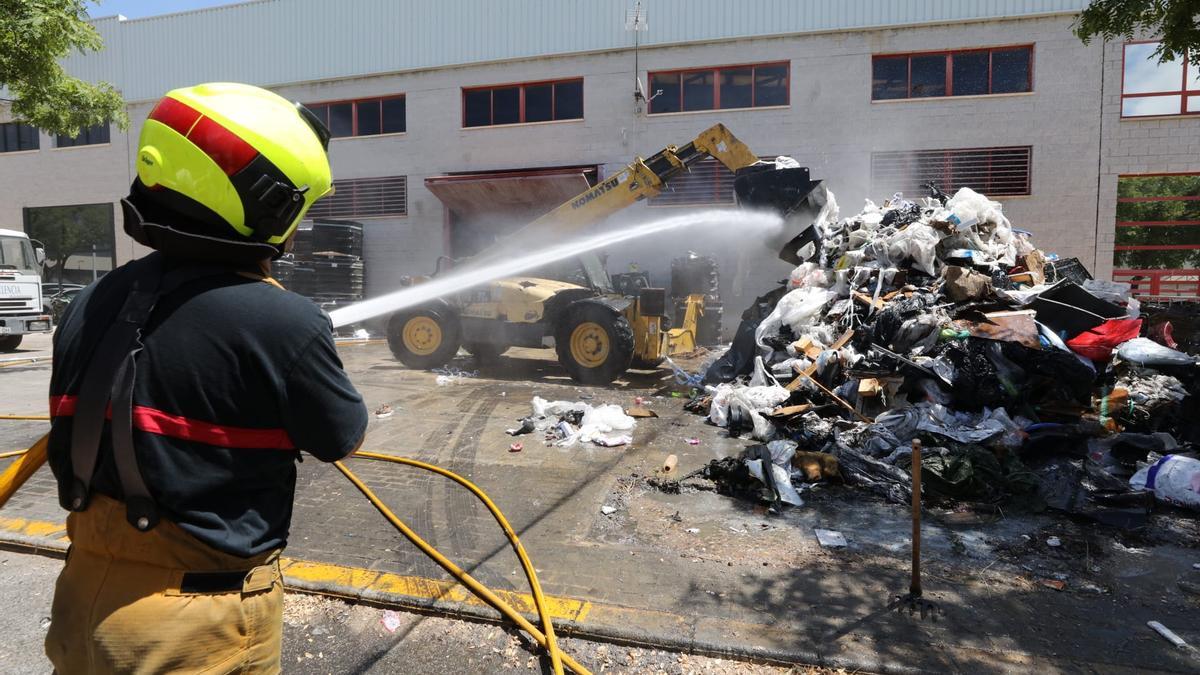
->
xmin=0 ymin=429 xmax=590 ymax=675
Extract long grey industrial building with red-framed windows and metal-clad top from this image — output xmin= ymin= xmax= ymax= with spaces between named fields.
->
xmin=0 ymin=0 xmax=1200 ymax=307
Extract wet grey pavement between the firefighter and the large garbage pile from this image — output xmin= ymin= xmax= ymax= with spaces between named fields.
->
xmin=0 ymin=333 xmax=1200 ymax=673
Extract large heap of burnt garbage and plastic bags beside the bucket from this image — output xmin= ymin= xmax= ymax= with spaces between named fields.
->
xmin=688 ymin=186 xmax=1200 ymax=526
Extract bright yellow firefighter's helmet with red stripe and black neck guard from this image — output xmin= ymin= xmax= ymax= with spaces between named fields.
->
xmin=122 ymin=83 xmax=332 ymax=261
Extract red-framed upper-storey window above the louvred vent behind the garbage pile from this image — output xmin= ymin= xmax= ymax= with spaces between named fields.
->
xmin=871 ymin=46 xmax=1033 ymax=101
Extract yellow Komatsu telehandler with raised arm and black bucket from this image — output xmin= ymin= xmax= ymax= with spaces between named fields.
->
xmin=388 ymin=124 xmax=823 ymax=384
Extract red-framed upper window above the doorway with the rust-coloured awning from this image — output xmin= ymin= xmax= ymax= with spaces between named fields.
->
xmin=462 ymin=78 xmax=583 ymax=126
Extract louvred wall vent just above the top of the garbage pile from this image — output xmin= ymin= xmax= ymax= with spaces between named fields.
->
xmin=871 ymin=145 xmax=1032 ymax=197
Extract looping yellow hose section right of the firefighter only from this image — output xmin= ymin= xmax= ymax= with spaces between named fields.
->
xmin=334 ymin=452 xmax=590 ymax=675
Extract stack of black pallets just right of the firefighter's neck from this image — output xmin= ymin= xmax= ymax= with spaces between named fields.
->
xmin=272 ymin=220 xmax=364 ymax=310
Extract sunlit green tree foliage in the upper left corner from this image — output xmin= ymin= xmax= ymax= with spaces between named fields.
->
xmin=0 ymin=0 xmax=128 ymax=136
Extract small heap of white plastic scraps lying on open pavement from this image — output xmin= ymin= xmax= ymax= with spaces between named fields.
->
xmin=505 ymin=396 xmax=637 ymax=448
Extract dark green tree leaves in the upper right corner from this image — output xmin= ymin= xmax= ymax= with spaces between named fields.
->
xmin=1074 ymin=0 xmax=1200 ymax=65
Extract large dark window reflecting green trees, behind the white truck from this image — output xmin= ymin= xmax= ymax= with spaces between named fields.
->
xmin=25 ymin=204 xmax=113 ymax=286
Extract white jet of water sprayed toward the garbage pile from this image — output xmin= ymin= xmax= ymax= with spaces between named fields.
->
xmin=329 ymin=210 xmax=784 ymax=328
